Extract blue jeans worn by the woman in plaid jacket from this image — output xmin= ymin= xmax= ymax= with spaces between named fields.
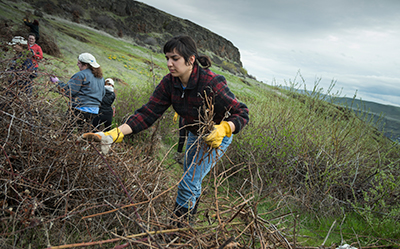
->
xmin=176 ymin=132 xmax=233 ymax=209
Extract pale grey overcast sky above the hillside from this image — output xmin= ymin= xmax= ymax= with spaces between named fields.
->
xmin=141 ymin=0 xmax=400 ymax=106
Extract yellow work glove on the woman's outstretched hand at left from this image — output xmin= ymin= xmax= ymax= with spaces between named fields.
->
xmin=81 ymin=128 xmax=124 ymax=154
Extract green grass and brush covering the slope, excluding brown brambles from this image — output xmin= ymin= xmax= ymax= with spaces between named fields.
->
xmin=0 ymin=2 xmax=400 ymax=247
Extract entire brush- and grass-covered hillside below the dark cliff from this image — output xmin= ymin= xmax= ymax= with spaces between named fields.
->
xmin=0 ymin=0 xmax=400 ymax=249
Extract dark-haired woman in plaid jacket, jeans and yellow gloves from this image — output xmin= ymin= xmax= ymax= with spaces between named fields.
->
xmin=83 ymin=36 xmax=249 ymax=226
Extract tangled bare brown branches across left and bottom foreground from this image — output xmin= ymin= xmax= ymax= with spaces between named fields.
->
xmin=0 ymin=53 xmax=291 ymax=248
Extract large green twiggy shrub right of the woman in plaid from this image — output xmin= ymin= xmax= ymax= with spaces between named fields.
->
xmin=225 ymin=78 xmax=400 ymax=215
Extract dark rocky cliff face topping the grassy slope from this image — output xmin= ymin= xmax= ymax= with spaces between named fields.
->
xmin=25 ymin=0 xmax=242 ymax=69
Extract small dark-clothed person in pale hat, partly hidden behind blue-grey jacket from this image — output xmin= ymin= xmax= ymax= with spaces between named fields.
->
xmin=92 ymin=78 xmax=115 ymax=131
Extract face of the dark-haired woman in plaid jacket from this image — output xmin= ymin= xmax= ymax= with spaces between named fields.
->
xmin=165 ymin=49 xmax=195 ymax=84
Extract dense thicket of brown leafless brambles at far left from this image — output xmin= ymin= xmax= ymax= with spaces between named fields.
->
xmin=0 ymin=40 xmax=173 ymax=248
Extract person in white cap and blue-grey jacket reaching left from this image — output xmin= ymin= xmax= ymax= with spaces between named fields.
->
xmin=50 ymin=53 xmax=106 ymax=131
